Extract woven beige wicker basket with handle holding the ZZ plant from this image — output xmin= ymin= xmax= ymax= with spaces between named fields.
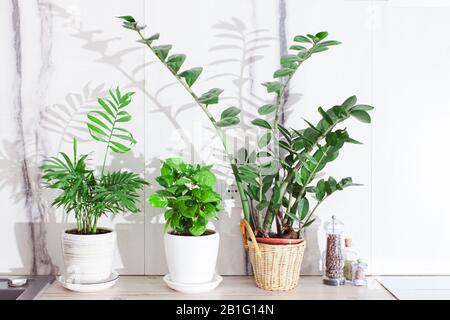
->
xmin=241 ymin=220 xmax=306 ymax=291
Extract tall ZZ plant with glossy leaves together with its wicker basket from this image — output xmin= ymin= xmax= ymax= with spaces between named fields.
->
xmin=119 ymin=16 xmax=373 ymax=290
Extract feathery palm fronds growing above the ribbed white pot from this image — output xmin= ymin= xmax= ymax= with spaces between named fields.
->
xmin=40 ymin=88 xmax=148 ymax=234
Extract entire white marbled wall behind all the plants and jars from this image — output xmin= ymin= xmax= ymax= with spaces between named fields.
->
xmin=0 ymin=0 xmax=450 ymax=274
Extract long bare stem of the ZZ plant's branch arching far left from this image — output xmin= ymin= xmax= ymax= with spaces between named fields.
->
xmin=137 ymin=30 xmax=250 ymax=221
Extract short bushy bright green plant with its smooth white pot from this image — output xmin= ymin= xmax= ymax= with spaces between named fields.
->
xmin=148 ymin=158 xmax=223 ymax=285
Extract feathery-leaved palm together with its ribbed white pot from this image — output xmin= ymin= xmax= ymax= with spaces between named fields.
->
xmin=40 ymin=88 xmax=147 ymax=284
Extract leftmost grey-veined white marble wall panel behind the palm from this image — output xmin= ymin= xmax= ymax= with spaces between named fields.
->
xmin=0 ymin=0 xmax=144 ymax=274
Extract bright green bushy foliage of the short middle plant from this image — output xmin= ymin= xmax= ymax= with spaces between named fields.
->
xmin=148 ymin=158 xmax=223 ymax=236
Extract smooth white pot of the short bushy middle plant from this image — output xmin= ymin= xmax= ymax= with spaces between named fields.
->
xmin=164 ymin=231 xmax=219 ymax=284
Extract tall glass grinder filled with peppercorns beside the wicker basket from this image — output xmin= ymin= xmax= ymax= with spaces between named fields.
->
xmin=323 ymin=216 xmax=345 ymax=286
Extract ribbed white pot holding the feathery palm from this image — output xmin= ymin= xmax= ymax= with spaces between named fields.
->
xmin=62 ymin=228 xmax=116 ymax=283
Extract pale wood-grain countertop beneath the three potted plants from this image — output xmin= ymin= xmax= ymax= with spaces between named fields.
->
xmin=40 ymin=276 xmax=395 ymax=300
